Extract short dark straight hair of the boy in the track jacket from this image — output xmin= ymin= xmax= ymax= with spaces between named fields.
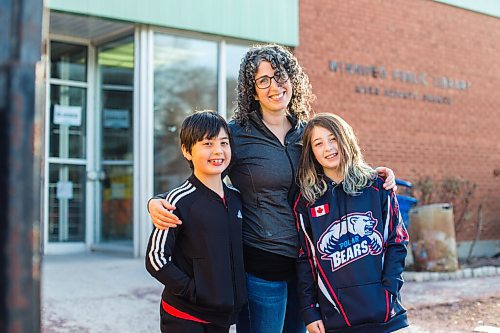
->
xmin=179 ymin=110 xmax=229 ymax=169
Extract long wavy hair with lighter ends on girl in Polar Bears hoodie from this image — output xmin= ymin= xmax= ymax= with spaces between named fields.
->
xmin=297 ymin=113 xmax=377 ymax=204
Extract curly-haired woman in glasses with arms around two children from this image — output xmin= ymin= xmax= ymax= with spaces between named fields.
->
xmin=148 ymin=45 xmax=394 ymax=333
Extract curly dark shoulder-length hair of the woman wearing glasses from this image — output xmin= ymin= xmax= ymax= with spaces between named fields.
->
xmin=233 ymin=44 xmax=314 ymax=126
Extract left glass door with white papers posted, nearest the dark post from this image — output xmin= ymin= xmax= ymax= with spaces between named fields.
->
xmin=44 ymin=41 xmax=88 ymax=249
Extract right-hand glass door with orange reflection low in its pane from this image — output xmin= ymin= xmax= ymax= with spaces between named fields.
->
xmin=96 ymin=36 xmax=134 ymax=249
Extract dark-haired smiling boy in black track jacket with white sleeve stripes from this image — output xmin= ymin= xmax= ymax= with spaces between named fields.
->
xmin=146 ymin=111 xmax=247 ymax=333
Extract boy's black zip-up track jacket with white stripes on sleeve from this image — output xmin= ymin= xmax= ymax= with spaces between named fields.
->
xmin=146 ymin=175 xmax=247 ymax=326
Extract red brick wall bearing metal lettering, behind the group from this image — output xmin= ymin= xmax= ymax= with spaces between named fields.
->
xmin=295 ymin=0 xmax=500 ymax=240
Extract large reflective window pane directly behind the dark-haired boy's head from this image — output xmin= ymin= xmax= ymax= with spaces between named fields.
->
xmin=154 ymin=34 xmax=217 ymax=192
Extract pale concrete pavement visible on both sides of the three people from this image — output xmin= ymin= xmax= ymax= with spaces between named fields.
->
xmin=42 ymin=253 xmax=500 ymax=333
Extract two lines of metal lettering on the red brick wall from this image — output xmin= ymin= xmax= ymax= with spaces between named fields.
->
xmin=330 ymin=60 xmax=472 ymax=105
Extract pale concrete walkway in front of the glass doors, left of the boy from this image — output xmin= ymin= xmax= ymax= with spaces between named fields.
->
xmin=42 ymin=253 xmax=163 ymax=333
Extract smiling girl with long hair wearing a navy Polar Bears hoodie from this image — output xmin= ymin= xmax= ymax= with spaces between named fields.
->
xmin=294 ymin=114 xmax=408 ymax=333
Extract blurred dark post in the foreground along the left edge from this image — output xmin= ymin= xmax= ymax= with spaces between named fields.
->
xmin=0 ymin=0 xmax=44 ymax=333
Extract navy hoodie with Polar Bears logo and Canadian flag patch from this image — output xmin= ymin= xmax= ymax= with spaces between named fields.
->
xmin=294 ymin=178 xmax=408 ymax=333
